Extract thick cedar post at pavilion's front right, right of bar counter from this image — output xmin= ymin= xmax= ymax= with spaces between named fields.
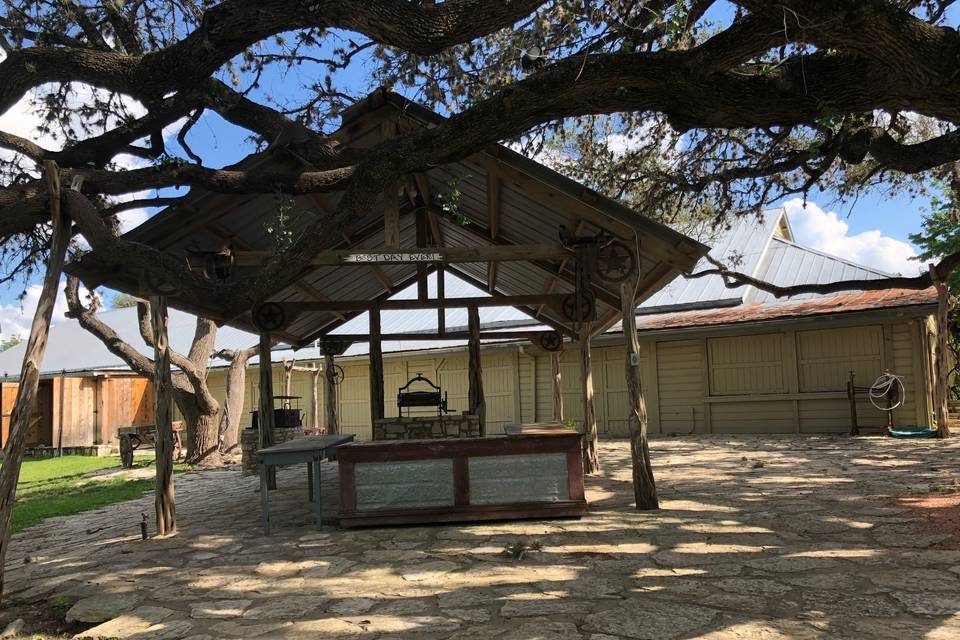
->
xmin=620 ymin=279 xmax=660 ymax=509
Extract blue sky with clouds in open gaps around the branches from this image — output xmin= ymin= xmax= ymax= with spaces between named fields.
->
xmin=0 ymin=6 xmax=948 ymax=337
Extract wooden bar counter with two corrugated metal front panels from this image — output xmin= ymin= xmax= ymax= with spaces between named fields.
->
xmin=337 ymin=430 xmax=587 ymax=527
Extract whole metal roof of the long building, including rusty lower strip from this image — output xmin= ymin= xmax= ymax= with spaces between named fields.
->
xmin=0 ymin=210 xmax=936 ymax=377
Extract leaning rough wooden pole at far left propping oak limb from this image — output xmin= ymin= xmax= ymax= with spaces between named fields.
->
xmin=0 ymin=162 xmax=70 ymax=600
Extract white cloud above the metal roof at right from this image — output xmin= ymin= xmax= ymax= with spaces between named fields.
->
xmin=783 ymin=198 xmax=921 ymax=276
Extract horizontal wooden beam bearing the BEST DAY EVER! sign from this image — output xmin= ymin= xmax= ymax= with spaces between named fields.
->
xmin=236 ymin=244 xmax=573 ymax=267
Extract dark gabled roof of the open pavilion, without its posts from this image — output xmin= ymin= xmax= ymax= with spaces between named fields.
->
xmin=67 ymin=91 xmax=707 ymax=346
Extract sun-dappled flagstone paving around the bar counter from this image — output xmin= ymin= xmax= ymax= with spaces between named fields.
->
xmin=7 ymin=437 xmax=960 ymax=640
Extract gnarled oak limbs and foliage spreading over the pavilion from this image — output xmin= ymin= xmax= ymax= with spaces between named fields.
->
xmin=0 ymin=0 xmax=960 ymax=592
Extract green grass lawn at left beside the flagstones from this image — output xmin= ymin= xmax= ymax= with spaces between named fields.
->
xmin=12 ymin=456 xmax=190 ymax=533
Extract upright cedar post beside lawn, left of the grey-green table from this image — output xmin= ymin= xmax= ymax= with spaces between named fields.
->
xmin=150 ymin=296 xmax=177 ymax=536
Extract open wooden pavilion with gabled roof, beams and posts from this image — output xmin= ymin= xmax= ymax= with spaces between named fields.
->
xmin=68 ymin=92 xmax=707 ymax=516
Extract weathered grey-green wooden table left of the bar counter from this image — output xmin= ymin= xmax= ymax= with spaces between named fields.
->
xmin=257 ymin=435 xmax=353 ymax=536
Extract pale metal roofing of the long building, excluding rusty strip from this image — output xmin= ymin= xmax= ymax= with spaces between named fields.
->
xmin=0 ymin=209 xmax=912 ymax=377
